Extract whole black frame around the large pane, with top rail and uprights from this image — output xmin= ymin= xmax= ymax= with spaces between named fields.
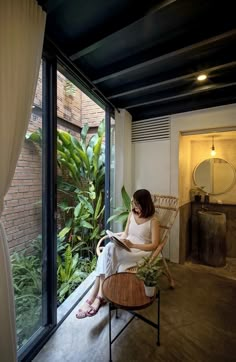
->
xmin=18 ymin=43 xmax=114 ymax=362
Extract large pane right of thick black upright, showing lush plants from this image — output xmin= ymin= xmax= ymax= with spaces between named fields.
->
xmin=57 ymin=71 xmax=105 ymax=314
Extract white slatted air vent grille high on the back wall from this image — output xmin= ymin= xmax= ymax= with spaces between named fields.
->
xmin=132 ymin=117 xmax=170 ymax=142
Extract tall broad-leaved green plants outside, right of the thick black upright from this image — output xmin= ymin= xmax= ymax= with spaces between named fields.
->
xmin=26 ymin=120 xmax=105 ymax=303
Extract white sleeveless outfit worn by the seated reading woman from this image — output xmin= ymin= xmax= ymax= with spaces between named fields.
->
xmin=95 ymin=214 xmax=155 ymax=277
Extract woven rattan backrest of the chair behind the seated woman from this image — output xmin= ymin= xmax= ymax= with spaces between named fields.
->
xmin=152 ymin=194 xmax=179 ymax=243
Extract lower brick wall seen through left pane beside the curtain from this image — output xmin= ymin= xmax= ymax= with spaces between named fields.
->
xmin=1 ymin=115 xmax=42 ymax=250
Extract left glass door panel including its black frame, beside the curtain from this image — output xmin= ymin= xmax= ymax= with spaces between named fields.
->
xmin=1 ymin=60 xmax=56 ymax=361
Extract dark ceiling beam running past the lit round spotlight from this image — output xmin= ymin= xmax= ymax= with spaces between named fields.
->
xmin=107 ymin=62 xmax=236 ymax=99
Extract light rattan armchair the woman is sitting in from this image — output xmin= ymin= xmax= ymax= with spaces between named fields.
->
xmin=96 ymin=194 xmax=179 ymax=288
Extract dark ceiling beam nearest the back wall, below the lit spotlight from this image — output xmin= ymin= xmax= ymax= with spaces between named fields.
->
xmin=125 ymin=82 xmax=236 ymax=109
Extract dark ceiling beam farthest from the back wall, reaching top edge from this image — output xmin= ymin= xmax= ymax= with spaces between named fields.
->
xmin=70 ymin=0 xmax=176 ymax=61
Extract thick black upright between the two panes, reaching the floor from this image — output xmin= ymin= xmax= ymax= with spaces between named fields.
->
xmin=18 ymin=55 xmax=57 ymax=362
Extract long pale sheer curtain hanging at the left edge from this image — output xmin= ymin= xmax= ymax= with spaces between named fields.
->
xmin=0 ymin=0 xmax=46 ymax=362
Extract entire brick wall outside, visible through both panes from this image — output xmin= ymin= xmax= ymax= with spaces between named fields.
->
xmin=1 ymin=67 xmax=105 ymax=252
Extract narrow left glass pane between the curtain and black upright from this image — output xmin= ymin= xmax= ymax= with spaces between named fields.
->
xmin=2 ymin=61 xmax=42 ymax=349
